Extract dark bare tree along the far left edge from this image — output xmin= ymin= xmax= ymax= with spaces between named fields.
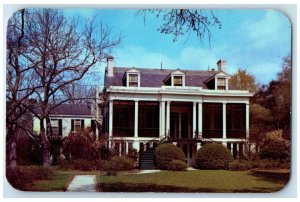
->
xmin=6 ymin=9 xmax=39 ymax=170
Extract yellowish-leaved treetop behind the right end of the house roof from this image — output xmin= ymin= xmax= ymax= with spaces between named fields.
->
xmin=229 ymin=69 xmax=257 ymax=93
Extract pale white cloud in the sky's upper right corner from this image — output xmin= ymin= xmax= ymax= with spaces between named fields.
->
xmin=242 ymin=9 xmax=290 ymax=48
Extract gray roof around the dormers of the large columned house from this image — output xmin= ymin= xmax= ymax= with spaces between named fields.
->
xmin=104 ymin=67 xmax=235 ymax=89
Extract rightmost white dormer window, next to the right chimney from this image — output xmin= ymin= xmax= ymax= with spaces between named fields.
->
xmin=205 ymin=72 xmax=230 ymax=90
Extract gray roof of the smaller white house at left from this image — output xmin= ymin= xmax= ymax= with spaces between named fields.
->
xmin=50 ymin=104 xmax=91 ymax=116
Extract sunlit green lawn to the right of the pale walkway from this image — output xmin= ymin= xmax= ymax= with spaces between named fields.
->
xmin=98 ymin=170 xmax=289 ymax=192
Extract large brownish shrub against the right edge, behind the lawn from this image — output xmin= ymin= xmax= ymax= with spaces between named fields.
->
xmin=259 ymin=130 xmax=290 ymax=160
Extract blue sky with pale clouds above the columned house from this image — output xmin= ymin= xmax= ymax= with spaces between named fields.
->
xmin=64 ymin=9 xmax=291 ymax=84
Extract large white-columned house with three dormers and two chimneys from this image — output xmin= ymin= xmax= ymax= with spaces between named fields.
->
xmin=103 ymin=56 xmax=252 ymax=165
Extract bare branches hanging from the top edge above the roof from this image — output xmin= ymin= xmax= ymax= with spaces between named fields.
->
xmin=137 ymin=9 xmax=221 ymax=42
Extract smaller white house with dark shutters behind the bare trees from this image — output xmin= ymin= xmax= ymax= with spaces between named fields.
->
xmin=33 ymin=104 xmax=97 ymax=138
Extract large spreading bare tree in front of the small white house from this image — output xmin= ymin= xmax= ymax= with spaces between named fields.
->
xmin=6 ymin=9 xmax=121 ymax=165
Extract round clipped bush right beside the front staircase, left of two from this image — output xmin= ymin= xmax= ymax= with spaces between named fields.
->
xmin=155 ymin=143 xmax=185 ymax=170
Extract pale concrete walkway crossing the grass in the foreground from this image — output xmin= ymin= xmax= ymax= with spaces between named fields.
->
xmin=67 ymin=175 xmax=97 ymax=192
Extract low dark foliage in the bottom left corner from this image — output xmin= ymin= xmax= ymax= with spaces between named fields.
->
xmin=6 ymin=166 xmax=53 ymax=191
